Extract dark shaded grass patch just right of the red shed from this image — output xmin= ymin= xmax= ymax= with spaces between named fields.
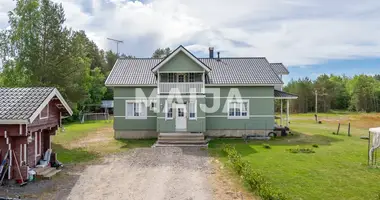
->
xmin=52 ymin=143 xmax=100 ymax=164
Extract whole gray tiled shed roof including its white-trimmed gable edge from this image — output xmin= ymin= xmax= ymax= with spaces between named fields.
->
xmin=0 ymin=87 xmax=72 ymax=124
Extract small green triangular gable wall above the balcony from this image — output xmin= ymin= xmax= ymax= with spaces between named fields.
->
xmin=159 ymin=52 xmax=204 ymax=72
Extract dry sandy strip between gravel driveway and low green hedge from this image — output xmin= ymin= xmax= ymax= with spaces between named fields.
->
xmin=209 ymin=159 xmax=259 ymax=200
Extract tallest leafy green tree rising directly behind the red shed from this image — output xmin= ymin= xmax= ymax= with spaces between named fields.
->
xmin=0 ymin=0 xmax=91 ymax=106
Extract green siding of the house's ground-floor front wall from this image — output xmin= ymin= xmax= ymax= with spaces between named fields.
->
xmin=114 ymin=87 xmax=274 ymax=132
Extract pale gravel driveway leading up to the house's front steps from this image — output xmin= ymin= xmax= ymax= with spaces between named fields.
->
xmin=68 ymin=147 xmax=213 ymax=200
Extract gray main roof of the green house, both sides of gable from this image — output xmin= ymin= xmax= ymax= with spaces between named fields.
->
xmin=105 ymin=58 xmax=283 ymax=86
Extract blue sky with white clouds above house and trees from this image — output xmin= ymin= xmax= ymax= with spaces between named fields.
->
xmin=0 ymin=0 xmax=380 ymax=81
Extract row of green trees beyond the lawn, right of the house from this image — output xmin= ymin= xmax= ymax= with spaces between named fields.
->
xmin=284 ymin=74 xmax=380 ymax=113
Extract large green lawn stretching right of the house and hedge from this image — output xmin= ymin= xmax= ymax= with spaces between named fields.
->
xmin=210 ymin=114 xmax=380 ymax=199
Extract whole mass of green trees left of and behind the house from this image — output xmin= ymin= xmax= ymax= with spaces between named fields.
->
xmin=0 ymin=0 xmax=170 ymax=120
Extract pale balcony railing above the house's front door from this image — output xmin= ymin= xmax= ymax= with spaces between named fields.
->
xmin=158 ymin=82 xmax=204 ymax=93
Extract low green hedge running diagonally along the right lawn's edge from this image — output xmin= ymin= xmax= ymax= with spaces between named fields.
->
xmin=222 ymin=144 xmax=288 ymax=200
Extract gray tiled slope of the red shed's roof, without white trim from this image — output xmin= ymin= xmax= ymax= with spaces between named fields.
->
xmin=0 ymin=87 xmax=54 ymax=120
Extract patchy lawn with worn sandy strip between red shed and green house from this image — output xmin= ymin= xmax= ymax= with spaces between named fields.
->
xmin=52 ymin=121 xmax=156 ymax=164
